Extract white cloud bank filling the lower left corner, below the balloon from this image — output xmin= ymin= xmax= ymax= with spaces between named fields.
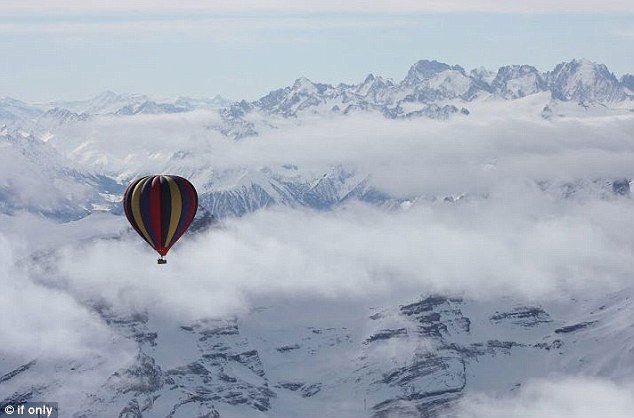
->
xmin=0 ymin=229 xmax=135 ymax=409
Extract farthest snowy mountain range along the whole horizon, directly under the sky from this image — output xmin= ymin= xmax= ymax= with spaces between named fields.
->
xmin=0 ymin=59 xmax=634 ymax=129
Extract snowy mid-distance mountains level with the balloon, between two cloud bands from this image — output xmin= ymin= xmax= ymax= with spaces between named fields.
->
xmin=0 ymin=128 xmax=631 ymax=222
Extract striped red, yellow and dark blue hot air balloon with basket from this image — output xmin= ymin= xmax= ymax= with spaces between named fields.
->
xmin=123 ymin=175 xmax=198 ymax=264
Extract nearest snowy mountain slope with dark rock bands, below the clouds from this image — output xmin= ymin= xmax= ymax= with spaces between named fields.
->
xmin=0 ymin=280 xmax=634 ymax=418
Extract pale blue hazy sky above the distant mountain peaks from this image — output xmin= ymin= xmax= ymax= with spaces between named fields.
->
xmin=0 ymin=0 xmax=634 ymax=101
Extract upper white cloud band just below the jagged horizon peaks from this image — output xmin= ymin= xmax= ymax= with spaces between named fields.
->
xmin=50 ymin=103 xmax=634 ymax=197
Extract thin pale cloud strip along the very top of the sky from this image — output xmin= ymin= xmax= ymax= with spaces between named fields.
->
xmin=2 ymin=0 xmax=632 ymax=15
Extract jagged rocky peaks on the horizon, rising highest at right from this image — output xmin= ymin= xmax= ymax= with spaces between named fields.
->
xmin=216 ymin=59 xmax=634 ymax=129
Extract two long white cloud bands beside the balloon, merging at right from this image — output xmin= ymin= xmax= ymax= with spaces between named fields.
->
xmin=34 ymin=103 xmax=634 ymax=318
